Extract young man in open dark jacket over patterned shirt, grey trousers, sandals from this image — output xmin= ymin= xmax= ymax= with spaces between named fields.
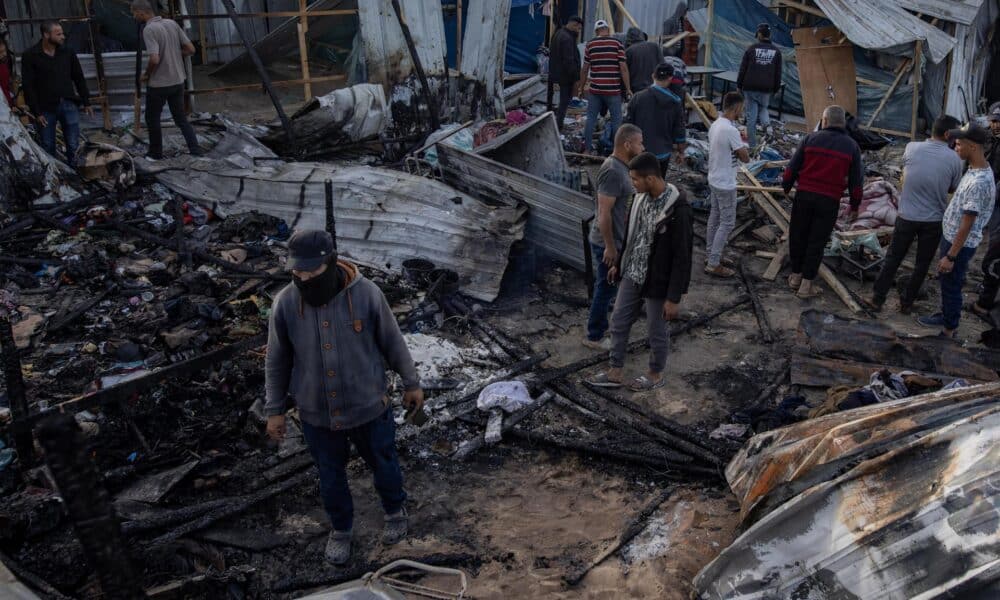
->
xmin=590 ymin=152 xmax=694 ymax=391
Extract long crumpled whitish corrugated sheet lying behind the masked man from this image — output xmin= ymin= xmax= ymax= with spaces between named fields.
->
xmin=136 ymin=143 xmax=526 ymax=301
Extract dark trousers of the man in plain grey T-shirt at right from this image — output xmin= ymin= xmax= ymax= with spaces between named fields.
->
xmin=873 ymin=217 xmax=941 ymax=306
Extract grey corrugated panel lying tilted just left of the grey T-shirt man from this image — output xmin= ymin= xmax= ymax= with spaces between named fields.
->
xmin=436 ymin=144 xmax=594 ymax=270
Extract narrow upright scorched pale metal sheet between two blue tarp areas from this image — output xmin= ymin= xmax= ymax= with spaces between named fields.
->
xmin=459 ymin=0 xmax=511 ymax=116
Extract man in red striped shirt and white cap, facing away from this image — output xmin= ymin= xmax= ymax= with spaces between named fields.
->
xmin=580 ymin=20 xmax=632 ymax=154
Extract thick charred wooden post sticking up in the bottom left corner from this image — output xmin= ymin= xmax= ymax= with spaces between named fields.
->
xmin=38 ymin=414 xmax=143 ymax=600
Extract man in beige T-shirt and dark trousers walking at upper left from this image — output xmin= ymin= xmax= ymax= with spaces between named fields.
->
xmin=132 ymin=0 xmax=204 ymax=160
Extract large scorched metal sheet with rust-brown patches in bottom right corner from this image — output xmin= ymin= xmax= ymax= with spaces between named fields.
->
xmin=694 ymin=383 xmax=1000 ymax=600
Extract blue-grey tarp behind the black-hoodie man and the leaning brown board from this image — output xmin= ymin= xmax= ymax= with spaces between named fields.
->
xmin=688 ymin=0 xmax=913 ymax=131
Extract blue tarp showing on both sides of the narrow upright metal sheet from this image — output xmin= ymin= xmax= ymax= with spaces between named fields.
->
xmin=441 ymin=0 xmax=549 ymax=73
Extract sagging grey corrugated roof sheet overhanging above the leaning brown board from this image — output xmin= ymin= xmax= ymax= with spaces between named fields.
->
xmin=816 ymin=0 xmax=955 ymax=63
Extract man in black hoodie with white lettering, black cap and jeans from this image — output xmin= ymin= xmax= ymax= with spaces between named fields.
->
xmin=736 ymin=23 xmax=781 ymax=148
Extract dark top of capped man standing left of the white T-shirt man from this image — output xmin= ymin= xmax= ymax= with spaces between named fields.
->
xmin=625 ymin=85 xmax=687 ymax=158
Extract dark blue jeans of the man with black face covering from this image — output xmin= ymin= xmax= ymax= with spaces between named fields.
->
xmin=302 ymin=409 xmax=406 ymax=531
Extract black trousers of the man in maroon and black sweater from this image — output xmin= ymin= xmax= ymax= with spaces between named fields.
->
xmin=788 ymin=191 xmax=840 ymax=281
